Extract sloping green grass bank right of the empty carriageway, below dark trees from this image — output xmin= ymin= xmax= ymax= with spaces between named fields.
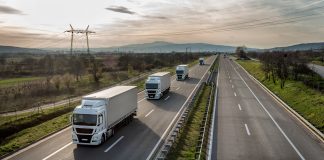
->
xmin=237 ymin=61 xmax=324 ymax=133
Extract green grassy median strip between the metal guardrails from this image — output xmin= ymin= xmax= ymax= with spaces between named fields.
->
xmin=167 ymin=85 xmax=212 ymax=159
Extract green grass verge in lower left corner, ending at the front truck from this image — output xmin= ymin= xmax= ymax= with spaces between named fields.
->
xmin=0 ymin=113 xmax=71 ymax=156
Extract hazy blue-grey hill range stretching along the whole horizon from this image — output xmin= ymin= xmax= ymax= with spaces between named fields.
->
xmin=0 ymin=41 xmax=324 ymax=54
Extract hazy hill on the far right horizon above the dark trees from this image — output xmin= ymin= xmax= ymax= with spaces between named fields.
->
xmin=269 ymin=42 xmax=324 ymax=51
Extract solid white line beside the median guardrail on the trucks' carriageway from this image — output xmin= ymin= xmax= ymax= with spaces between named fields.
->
xmin=146 ymin=55 xmax=211 ymax=160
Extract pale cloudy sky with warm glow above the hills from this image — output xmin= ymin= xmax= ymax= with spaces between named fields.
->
xmin=0 ymin=0 xmax=324 ymax=48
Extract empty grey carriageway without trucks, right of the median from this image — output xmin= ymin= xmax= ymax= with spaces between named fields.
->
xmin=211 ymin=57 xmax=324 ymax=160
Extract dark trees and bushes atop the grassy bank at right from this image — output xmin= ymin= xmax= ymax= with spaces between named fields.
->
xmin=248 ymin=51 xmax=323 ymax=90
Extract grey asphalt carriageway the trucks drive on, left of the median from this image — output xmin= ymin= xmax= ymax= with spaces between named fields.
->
xmin=5 ymin=56 xmax=216 ymax=160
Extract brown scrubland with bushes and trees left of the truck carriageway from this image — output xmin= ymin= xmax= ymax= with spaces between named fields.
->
xmin=0 ymin=53 xmax=206 ymax=112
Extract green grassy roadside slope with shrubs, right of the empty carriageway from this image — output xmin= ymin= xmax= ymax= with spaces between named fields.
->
xmin=237 ymin=59 xmax=324 ymax=133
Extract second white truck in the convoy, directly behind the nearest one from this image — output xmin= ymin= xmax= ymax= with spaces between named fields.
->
xmin=145 ymin=72 xmax=171 ymax=99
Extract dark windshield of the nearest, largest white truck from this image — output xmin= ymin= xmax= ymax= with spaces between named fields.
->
xmin=73 ymin=114 xmax=97 ymax=126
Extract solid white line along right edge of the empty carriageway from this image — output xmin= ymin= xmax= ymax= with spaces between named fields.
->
xmin=230 ymin=63 xmax=305 ymax=160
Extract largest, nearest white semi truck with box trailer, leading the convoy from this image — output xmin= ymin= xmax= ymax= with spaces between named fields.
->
xmin=71 ymin=86 xmax=137 ymax=145
